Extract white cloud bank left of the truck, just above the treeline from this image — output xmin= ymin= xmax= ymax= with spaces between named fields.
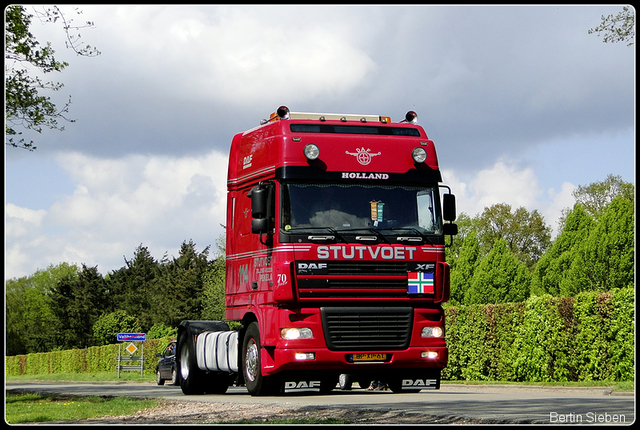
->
xmin=5 ymin=152 xmax=227 ymax=278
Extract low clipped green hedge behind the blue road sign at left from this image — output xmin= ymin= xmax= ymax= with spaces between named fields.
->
xmin=6 ymin=337 xmax=174 ymax=376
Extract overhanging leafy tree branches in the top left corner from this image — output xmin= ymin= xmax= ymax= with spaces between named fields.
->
xmin=5 ymin=5 xmax=100 ymax=151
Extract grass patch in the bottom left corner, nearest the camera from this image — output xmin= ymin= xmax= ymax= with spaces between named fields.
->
xmin=5 ymin=393 xmax=158 ymax=424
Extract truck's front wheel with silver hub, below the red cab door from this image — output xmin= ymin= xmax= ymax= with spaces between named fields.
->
xmin=242 ymin=322 xmax=281 ymax=396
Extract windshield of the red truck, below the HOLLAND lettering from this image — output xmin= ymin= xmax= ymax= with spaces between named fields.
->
xmin=281 ymin=183 xmax=442 ymax=234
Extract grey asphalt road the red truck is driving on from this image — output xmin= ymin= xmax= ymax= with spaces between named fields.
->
xmin=5 ymin=382 xmax=635 ymax=425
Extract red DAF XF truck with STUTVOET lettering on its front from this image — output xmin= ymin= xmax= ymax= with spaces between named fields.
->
xmin=176 ymin=106 xmax=457 ymax=395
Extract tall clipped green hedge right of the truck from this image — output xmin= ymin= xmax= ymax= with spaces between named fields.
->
xmin=443 ymin=288 xmax=635 ymax=382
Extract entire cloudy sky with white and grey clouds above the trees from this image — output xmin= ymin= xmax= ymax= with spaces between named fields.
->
xmin=5 ymin=6 xmax=635 ymax=279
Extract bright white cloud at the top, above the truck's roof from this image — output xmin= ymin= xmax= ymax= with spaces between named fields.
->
xmin=85 ymin=6 xmax=376 ymax=106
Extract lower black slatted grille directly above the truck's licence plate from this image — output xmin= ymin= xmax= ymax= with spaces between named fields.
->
xmin=320 ymin=307 xmax=413 ymax=351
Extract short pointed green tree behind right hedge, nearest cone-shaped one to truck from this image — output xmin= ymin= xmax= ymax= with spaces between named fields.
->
xmin=464 ymin=239 xmax=531 ymax=304
